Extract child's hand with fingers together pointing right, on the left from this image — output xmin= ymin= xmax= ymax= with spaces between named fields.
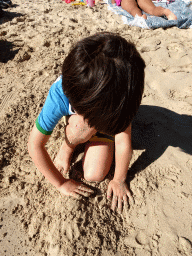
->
xmin=58 ymin=179 xmax=94 ymax=198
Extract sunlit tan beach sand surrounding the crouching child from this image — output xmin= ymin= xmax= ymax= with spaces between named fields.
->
xmin=0 ymin=0 xmax=192 ymax=256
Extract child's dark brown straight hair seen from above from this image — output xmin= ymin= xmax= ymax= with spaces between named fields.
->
xmin=62 ymin=32 xmax=145 ymax=135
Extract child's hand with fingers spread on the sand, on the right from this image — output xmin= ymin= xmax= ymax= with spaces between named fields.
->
xmin=107 ymin=180 xmax=133 ymax=213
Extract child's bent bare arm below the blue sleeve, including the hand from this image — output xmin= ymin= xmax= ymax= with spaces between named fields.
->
xmin=28 ymin=126 xmax=92 ymax=197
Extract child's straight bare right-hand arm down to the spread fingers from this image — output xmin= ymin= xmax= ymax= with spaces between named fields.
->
xmin=107 ymin=125 xmax=132 ymax=212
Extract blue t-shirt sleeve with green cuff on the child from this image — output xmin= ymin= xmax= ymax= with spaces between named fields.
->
xmin=35 ymin=77 xmax=69 ymax=135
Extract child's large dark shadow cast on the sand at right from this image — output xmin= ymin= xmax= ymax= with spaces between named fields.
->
xmin=127 ymin=105 xmax=192 ymax=183
